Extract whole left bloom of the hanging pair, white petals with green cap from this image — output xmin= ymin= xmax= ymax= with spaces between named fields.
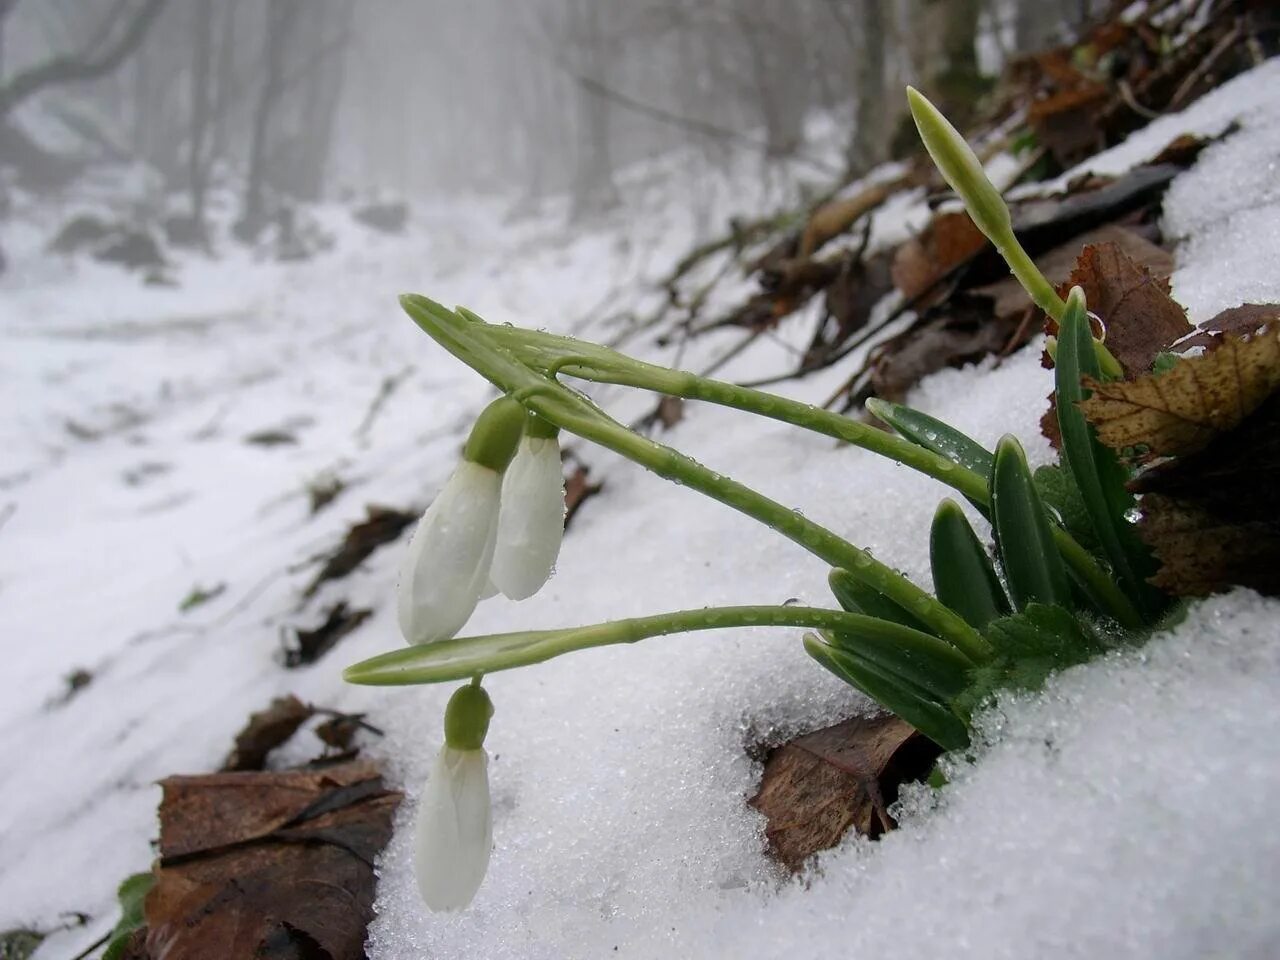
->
xmin=397 ymin=397 xmax=525 ymax=644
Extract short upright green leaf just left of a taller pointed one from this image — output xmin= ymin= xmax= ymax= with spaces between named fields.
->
xmin=929 ymin=499 xmax=1009 ymax=630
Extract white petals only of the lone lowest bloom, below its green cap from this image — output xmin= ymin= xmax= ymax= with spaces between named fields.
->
xmin=413 ymin=746 xmax=493 ymax=910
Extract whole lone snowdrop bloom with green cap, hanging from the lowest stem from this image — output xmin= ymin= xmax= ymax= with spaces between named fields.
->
xmin=413 ymin=681 xmax=493 ymax=911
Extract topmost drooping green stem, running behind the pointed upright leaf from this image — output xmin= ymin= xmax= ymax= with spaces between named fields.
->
xmin=484 ymin=325 xmax=1143 ymax=627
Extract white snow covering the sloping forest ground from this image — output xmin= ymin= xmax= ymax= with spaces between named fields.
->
xmin=0 ymin=63 xmax=1280 ymax=960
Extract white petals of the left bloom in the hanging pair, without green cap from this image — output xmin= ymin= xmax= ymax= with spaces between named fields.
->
xmin=397 ymin=461 xmax=502 ymax=644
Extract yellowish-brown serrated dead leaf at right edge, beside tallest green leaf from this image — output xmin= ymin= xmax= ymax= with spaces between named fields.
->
xmin=1080 ymin=324 xmax=1280 ymax=458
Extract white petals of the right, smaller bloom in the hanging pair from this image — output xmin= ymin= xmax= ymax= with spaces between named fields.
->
xmin=489 ymin=436 xmax=564 ymax=600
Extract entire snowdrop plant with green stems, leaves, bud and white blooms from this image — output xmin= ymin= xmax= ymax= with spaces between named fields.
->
xmin=344 ymin=91 xmax=1170 ymax=926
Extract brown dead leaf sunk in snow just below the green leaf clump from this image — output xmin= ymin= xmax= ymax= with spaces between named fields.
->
xmin=748 ymin=714 xmax=938 ymax=870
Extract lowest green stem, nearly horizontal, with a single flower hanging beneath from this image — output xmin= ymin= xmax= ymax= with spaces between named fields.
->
xmin=343 ymin=607 xmax=967 ymax=686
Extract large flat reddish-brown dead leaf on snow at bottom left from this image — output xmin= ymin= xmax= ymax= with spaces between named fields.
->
xmin=146 ymin=762 xmax=399 ymax=960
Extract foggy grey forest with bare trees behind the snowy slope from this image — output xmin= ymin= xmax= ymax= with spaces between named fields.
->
xmin=0 ymin=0 xmax=1089 ymax=252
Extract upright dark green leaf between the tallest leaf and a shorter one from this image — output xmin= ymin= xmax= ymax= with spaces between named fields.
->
xmin=991 ymin=436 xmax=1071 ymax=609
